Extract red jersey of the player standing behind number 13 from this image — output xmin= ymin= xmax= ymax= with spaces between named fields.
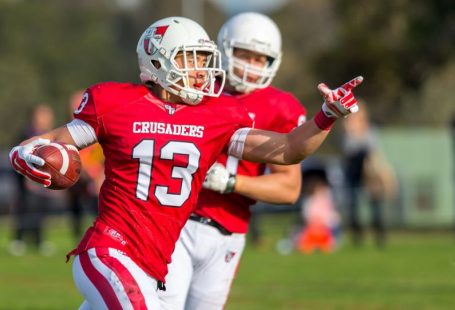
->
xmin=195 ymin=87 xmax=306 ymax=233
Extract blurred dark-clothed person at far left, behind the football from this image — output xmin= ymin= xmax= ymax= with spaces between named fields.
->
xmin=8 ymin=104 xmax=62 ymax=256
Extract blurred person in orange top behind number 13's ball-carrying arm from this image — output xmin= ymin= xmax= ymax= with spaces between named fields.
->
xmin=68 ymin=90 xmax=104 ymax=240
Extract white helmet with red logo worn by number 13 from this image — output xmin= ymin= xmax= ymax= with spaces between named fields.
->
xmin=136 ymin=17 xmax=225 ymax=105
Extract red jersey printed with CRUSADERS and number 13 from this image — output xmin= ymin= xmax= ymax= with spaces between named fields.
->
xmin=69 ymin=83 xmax=252 ymax=281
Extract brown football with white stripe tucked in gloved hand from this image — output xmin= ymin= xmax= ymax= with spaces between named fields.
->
xmin=33 ymin=142 xmax=81 ymax=189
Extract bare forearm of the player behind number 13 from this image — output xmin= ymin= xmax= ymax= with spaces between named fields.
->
xmin=234 ymin=168 xmax=301 ymax=204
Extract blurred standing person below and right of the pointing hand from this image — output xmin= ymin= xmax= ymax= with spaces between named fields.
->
xmin=342 ymin=105 xmax=396 ymax=247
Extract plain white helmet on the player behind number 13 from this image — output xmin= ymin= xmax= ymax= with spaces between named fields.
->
xmin=218 ymin=12 xmax=282 ymax=93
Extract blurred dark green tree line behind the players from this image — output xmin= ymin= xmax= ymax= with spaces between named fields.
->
xmin=0 ymin=0 xmax=455 ymax=148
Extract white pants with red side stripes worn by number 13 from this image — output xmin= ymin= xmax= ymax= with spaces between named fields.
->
xmin=73 ymin=248 xmax=161 ymax=310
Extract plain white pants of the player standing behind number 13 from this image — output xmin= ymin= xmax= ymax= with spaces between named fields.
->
xmin=158 ymin=220 xmax=246 ymax=310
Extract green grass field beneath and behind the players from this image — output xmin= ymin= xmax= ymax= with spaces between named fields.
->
xmin=0 ymin=215 xmax=455 ymax=310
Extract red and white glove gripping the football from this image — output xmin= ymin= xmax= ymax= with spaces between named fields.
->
xmin=9 ymin=138 xmax=51 ymax=187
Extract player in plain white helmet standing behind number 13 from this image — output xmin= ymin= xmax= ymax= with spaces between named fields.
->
xmin=158 ymin=13 xmax=306 ymax=310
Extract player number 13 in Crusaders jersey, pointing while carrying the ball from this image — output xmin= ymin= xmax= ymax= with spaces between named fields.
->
xmin=10 ymin=17 xmax=362 ymax=309
